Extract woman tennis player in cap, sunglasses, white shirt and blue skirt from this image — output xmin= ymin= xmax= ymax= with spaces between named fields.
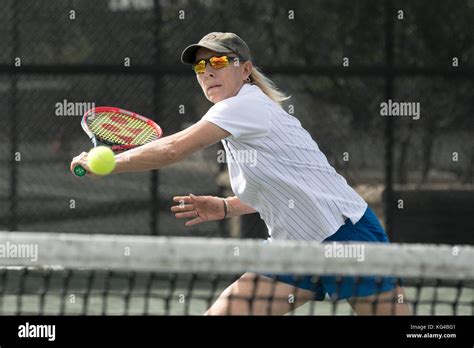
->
xmin=71 ymin=32 xmax=410 ymax=315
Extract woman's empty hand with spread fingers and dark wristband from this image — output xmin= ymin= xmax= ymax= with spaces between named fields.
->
xmin=171 ymin=194 xmax=225 ymax=226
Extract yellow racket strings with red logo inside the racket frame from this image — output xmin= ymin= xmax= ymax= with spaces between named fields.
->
xmin=87 ymin=112 xmax=158 ymax=146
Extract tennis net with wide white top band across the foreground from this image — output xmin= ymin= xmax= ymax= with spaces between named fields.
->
xmin=0 ymin=232 xmax=474 ymax=315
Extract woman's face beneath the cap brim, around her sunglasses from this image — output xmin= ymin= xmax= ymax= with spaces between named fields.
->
xmin=196 ymin=47 xmax=252 ymax=104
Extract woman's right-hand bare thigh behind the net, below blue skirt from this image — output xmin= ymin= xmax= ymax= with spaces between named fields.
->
xmin=347 ymin=287 xmax=412 ymax=315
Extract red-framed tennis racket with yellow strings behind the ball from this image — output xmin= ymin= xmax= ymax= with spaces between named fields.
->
xmin=74 ymin=106 xmax=163 ymax=177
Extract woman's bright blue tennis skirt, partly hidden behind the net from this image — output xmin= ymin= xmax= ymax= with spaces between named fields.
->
xmin=263 ymin=208 xmax=400 ymax=301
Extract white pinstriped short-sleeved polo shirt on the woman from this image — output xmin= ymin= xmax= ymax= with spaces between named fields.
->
xmin=202 ymin=84 xmax=367 ymax=241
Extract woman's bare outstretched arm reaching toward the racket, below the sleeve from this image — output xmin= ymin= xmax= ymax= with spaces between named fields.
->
xmin=113 ymin=121 xmax=230 ymax=173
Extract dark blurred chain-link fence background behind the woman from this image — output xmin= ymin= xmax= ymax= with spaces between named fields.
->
xmin=0 ymin=0 xmax=474 ymax=244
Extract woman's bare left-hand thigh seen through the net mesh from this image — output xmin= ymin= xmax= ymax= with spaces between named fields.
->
xmin=205 ymin=273 xmax=315 ymax=315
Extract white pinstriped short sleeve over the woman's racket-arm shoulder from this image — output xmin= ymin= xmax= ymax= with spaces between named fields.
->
xmin=202 ymin=87 xmax=271 ymax=139
